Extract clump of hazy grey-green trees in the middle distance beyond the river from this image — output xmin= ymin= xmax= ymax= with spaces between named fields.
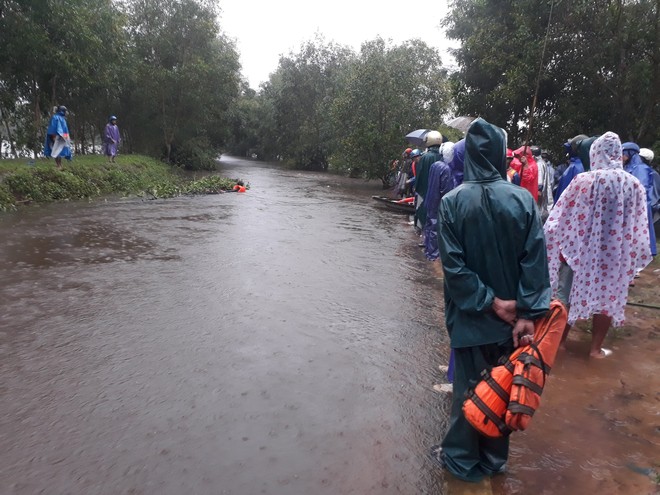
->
xmin=230 ymin=38 xmax=449 ymax=178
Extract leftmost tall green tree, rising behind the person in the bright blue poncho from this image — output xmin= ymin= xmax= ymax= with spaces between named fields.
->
xmin=0 ymin=0 xmax=119 ymax=155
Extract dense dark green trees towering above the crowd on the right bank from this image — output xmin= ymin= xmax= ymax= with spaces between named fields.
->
xmin=445 ymin=0 xmax=660 ymax=154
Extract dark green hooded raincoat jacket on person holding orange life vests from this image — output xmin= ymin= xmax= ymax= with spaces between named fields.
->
xmin=439 ymin=119 xmax=551 ymax=348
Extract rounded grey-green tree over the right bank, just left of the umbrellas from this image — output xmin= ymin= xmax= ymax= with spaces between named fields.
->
xmin=333 ymin=38 xmax=449 ymax=178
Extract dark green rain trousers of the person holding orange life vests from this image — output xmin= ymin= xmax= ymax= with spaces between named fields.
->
xmin=442 ymin=340 xmax=513 ymax=482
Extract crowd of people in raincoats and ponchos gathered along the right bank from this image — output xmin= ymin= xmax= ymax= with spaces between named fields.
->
xmin=396 ymin=119 xmax=660 ymax=481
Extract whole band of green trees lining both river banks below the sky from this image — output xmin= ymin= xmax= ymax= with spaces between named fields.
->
xmin=0 ymin=0 xmax=660 ymax=186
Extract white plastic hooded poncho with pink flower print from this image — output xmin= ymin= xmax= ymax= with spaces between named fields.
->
xmin=544 ymin=132 xmax=651 ymax=326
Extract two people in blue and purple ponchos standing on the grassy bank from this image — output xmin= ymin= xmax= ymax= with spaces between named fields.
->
xmin=44 ymin=105 xmax=121 ymax=168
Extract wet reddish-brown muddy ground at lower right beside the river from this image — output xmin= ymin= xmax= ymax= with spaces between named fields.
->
xmin=493 ymin=260 xmax=660 ymax=495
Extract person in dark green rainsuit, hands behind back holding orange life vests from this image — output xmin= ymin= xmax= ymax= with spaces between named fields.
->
xmin=432 ymin=119 xmax=551 ymax=482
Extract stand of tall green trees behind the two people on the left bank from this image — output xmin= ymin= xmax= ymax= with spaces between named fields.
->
xmin=0 ymin=0 xmax=240 ymax=168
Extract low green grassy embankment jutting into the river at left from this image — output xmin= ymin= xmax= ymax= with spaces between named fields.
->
xmin=0 ymin=155 xmax=245 ymax=211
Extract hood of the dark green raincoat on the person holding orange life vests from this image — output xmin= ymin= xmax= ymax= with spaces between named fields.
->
xmin=464 ymin=118 xmax=507 ymax=182
